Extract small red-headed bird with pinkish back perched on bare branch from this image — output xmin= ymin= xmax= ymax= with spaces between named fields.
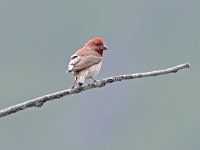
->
xmin=66 ymin=38 xmax=107 ymax=88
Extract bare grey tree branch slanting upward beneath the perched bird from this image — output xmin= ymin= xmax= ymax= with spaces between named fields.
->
xmin=0 ymin=63 xmax=190 ymax=117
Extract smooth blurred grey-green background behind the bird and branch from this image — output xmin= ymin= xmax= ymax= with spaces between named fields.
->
xmin=0 ymin=0 xmax=200 ymax=150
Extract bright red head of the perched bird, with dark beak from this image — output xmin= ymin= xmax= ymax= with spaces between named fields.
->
xmin=85 ymin=38 xmax=108 ymax=55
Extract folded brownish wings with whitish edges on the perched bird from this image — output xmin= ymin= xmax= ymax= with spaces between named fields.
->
xmin=68 ymin=55 xmax=102 ymax=72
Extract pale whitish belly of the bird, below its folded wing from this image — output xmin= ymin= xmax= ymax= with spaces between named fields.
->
xmin=86 ymin=62 xmax=102 ymax=79
